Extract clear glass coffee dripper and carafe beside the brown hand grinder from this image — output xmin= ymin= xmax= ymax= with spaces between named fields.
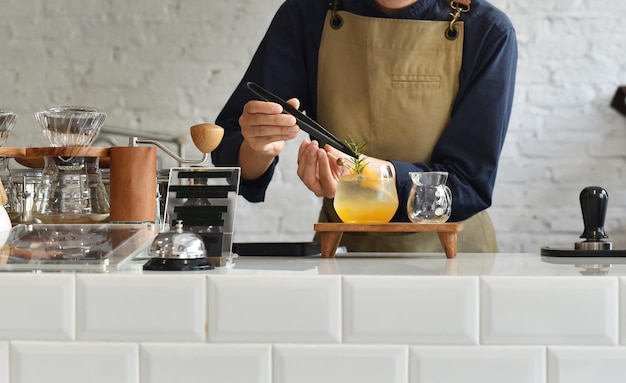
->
xmin=33 ymin=106 xmax=110 ymax=223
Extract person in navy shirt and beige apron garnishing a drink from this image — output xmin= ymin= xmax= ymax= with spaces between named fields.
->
xmin=212 ymin=0 xmax=517 ymax=252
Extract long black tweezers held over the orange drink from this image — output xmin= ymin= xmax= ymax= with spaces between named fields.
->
xmin=246 ymin=82 xmax=356 ymax=157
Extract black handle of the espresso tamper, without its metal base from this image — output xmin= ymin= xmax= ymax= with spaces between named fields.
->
xmin=580 ymin=186 xmax=609 ymax=242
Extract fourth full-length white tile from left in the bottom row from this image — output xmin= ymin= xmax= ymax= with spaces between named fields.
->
xmin=409 ymin=346 xmax=546 ymax=383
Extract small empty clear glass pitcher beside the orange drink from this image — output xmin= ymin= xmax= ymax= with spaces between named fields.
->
xmin=407 ymin=172 xmax=452 ymax=223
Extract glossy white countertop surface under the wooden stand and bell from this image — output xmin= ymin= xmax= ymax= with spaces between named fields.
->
xmin=120 ymin=253 xmax=626 ymax=276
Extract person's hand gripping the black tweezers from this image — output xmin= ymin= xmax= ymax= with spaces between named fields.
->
xmin=239 ymin=98 xmax=300 ymax=158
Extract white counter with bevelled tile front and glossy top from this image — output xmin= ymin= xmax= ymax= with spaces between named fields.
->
xmin=0 ymin=254 xmax=626 ymax=383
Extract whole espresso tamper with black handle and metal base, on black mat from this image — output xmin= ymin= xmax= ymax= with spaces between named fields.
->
xmin=574 ymin=186 xmax=613 ymax=250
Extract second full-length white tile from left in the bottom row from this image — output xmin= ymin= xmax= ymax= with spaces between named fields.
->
xmin=140 ymin=343 xmax=272 ymax=383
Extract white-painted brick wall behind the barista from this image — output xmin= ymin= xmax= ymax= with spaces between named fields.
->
xmin=0 ymin=0 xmax=626 ymax=252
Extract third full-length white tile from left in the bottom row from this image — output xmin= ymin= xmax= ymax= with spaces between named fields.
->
xmin=273 ymin=345 xmax=408 ymax=383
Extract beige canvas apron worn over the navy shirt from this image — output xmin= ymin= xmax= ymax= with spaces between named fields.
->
xmin=317 ymin=11 xmax=497 ymax=252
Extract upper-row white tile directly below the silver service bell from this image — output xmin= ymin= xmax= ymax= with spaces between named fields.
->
xmin=76 ymin=274 xmax=206 ymax=341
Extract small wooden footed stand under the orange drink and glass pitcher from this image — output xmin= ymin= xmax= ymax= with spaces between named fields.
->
xmin=313 ymin=222 xmax=463 ymax=258
